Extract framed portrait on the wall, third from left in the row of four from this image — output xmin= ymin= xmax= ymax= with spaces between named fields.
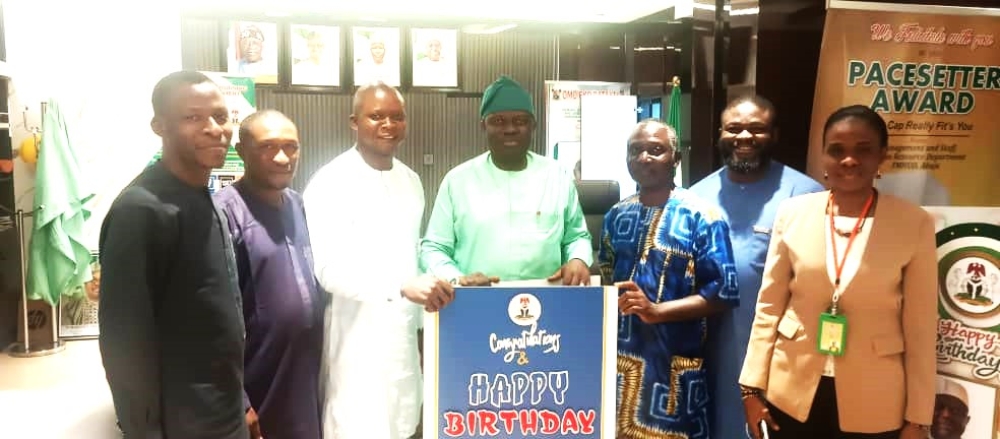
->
xmin=351 ymin=27 xmax=401 ymax=87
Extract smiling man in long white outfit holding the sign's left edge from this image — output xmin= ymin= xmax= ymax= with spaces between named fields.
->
xmin=303 ymin=83 xmax=454 ymax=439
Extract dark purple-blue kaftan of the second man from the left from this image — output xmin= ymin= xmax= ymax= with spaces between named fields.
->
xmin=215 ymin=183 xmax=325 ymax=439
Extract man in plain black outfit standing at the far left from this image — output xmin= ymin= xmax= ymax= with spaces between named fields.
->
xmin=100 ymin=71 xmax=247 ymax=439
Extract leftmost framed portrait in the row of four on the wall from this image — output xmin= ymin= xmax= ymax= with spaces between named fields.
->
xmin=226 ymin=21 xmax=279 ymax=84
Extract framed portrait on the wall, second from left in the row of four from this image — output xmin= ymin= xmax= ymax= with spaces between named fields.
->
xmin=289 ymin=24 xmax=341 ymax=87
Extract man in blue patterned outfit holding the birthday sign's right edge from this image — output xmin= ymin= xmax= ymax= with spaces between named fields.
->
xmin=598 ymin=120 xmax=739 ymax=439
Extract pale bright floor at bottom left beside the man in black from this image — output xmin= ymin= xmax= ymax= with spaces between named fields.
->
xmin=0 ymin=340 xmax=121 ymax=439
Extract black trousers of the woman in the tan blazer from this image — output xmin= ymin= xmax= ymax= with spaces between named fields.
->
xmin=767 ymin=377 xmax=899 ymax=439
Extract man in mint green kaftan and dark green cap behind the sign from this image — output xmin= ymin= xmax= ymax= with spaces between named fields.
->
xmin=420 ymin=76 xmax=593 ymax=286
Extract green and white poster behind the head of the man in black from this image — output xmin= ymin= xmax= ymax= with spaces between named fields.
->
xmin=150 ymin=72 xmax=257 ymax=193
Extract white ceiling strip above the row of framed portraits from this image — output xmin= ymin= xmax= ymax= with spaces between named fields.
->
xmin=176 ymin=0 xmax=683 ymax=23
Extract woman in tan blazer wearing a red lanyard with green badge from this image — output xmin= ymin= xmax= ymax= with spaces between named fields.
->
xmin=740 ymin=105 xmax=937 ymax=439
